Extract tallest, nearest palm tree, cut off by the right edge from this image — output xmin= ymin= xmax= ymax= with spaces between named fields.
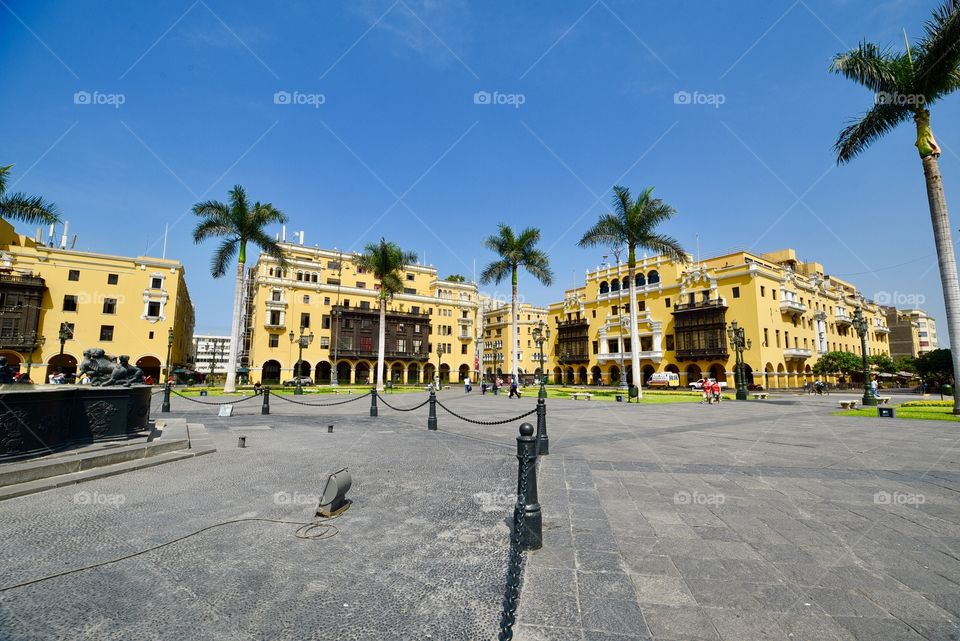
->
xmin=830 ymin=0 xmax=960 ymax=414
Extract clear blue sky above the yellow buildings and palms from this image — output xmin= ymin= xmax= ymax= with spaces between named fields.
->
xmin=0 ymin=0 xmax=960 ymax=343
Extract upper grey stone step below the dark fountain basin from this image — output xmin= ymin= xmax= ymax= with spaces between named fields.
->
xmin=0 ymin=438 xmax=187 ymax=487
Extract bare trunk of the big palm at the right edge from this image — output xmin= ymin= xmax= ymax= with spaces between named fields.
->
xmin=923 ymin=153 xmax=960 ymax=414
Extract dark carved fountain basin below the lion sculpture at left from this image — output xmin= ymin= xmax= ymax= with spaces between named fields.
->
xmin=0 ymin=385 xmax=153 ymax=462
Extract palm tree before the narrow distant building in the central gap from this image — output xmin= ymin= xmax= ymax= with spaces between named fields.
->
xmin=480 ymin=223 xmax=553 ymax=384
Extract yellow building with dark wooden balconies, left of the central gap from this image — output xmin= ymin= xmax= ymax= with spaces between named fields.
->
xmin=241 ymin=242 xmax=479 ymax=384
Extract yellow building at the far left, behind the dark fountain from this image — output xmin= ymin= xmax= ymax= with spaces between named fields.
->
xmin=0 ymin=220 xmax=194 ymax=383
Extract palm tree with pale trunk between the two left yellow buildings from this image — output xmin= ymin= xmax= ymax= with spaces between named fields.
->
xmin=193 ymin=185 xmax=287 ymax=392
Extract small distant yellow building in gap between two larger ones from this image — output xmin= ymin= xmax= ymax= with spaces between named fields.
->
xmin=481 ymin=298 xmax=550 ymax=383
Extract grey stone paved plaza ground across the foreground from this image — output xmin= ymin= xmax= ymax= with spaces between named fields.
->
xmin=0 ymin=390 xmax=960 ymax=641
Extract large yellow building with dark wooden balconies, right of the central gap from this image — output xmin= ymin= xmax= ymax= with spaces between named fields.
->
xmin=549 ymin=249 xmax=890 ymax=388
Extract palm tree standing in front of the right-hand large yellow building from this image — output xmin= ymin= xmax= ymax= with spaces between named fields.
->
xmin=579 ymin=185 xmax=687 ymax=395
